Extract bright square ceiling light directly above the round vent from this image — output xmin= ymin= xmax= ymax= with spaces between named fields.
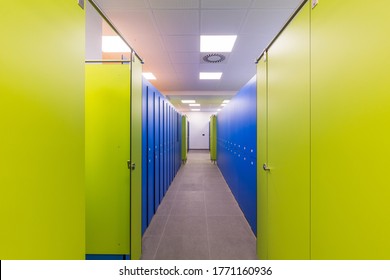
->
xmin=200 ymin=35 xmax=237 ymax=52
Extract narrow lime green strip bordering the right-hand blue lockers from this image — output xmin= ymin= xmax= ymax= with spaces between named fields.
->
xmin=257 ymin=56 xmax=268 ymax=260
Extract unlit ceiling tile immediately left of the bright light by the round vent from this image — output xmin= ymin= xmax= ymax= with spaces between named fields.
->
xmin=163 ymin=36 xmax=200 ymax=52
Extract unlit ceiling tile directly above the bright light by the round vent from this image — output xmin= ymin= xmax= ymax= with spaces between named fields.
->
xmin=200 ymin=10 xmax=246 ymax=35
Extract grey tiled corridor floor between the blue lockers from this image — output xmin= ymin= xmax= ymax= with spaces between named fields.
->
xmin=142 ymin=151 xmax=257 ymax=260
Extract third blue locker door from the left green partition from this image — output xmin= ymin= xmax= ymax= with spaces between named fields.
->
xmin=154 ymin=92 xmax=160 ymax=209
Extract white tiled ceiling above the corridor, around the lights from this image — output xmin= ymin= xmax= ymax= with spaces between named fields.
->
xmin=94 ymin=0 xmax=302 ymax=111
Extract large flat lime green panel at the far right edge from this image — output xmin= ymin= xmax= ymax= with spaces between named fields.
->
xmin=311 ymin=0 xmax=390 ymax=259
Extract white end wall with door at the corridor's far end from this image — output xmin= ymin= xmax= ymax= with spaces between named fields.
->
xmin=186 ymin=112 xmax=212 ymax=150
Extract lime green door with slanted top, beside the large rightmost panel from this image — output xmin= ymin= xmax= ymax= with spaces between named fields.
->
xmin=268 ymin=4 xmax=310 ymax=259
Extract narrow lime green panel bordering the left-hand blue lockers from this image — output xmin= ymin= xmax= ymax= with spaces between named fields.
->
xmin=130 ymin=55 xmax=142 ymax=260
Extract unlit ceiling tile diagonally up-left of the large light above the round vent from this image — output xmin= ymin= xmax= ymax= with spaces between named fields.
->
xmin=154 ymin=10 xmax=199 ymax=35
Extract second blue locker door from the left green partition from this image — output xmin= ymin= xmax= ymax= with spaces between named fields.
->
xmin=147 ymin=87 xmax=155 ymax=225
